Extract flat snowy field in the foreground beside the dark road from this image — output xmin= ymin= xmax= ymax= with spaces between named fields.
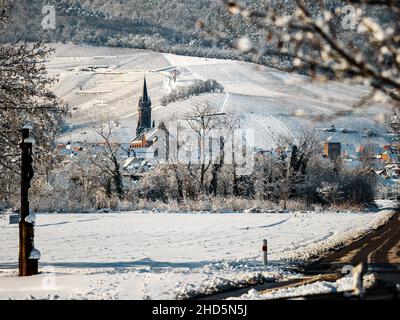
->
xmin=0 ymin=202 xmax=392 ymax=299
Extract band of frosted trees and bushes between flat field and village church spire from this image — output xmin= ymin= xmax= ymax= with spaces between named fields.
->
xmin=21 ymin=104 xmax=375 ymax=212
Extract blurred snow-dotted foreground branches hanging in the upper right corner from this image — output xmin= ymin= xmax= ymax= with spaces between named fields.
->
xmin=217 ymin=0 xmax=400 ymax=107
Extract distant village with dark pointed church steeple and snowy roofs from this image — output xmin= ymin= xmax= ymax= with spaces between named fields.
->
xmin=57 ymin=79 xmax=400 ymax=199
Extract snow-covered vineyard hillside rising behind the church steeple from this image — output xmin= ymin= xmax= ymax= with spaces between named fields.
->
xmin=47 ymin=45 xmax=390 ymax=149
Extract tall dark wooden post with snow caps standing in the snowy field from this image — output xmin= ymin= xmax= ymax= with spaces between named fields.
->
xmin=19 ymin=125 xmax=39 ymax=277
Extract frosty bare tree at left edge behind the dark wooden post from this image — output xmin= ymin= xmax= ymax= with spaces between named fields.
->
xmin=0 ymin=6 xmax=67 ymax=208
